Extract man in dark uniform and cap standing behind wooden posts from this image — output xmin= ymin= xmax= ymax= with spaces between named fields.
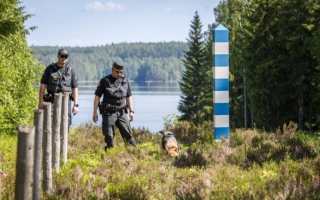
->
xmin=38 ymin=49 xmax=79 ymax=127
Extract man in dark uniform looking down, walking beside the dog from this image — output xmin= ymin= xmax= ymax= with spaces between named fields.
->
xmin=92 ymin=63 xmax=136 ymax=150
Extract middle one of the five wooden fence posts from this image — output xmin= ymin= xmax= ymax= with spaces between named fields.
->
xmin=42 ymin=102 xmax=52 ymax=193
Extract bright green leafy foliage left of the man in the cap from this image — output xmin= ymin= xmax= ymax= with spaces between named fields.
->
xmin=0 ymin=1 xmax=42 ymax=132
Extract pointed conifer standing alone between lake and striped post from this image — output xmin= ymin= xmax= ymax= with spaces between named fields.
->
xmin=178 ymin=12 xmax=212 ymax=125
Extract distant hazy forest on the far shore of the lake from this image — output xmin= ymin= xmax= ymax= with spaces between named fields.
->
xmin=31 ymin=42 xmax=187 ymax=81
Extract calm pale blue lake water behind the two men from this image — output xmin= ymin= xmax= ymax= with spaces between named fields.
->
xmin=72 ymin=82 xmax=181 ymax=132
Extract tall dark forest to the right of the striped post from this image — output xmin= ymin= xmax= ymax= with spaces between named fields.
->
xmin=214 ymin=0 xmax=320 ymax=131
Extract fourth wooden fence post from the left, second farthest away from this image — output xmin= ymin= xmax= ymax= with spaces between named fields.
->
xmin=52 ymin=93 xmax=62 ymax=173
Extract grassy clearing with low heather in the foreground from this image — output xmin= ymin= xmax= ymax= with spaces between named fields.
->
xmin=0 ymin=122 xmax=320 ymax=199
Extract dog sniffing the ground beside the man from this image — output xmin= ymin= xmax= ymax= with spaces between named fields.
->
xmin=160 ymin=131 xmax=179 ymax=157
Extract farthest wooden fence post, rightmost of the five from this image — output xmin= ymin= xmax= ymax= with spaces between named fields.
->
xmin=61 ymin=92 xmax=70 ymax=165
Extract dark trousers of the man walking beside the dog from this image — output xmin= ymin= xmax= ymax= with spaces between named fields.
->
xmin=102 ymin=109 xmax=136 ymax=149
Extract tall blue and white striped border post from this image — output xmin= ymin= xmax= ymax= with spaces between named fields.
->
xmin=212 ymin=24 xmax=230 ymax=140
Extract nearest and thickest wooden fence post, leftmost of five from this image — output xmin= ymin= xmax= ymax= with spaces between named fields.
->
xmin=15 ymin=126 xmax=35 ymax=200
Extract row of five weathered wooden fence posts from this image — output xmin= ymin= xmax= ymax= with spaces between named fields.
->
xmin=15 ymin=93 xmax=69 ymax=200
